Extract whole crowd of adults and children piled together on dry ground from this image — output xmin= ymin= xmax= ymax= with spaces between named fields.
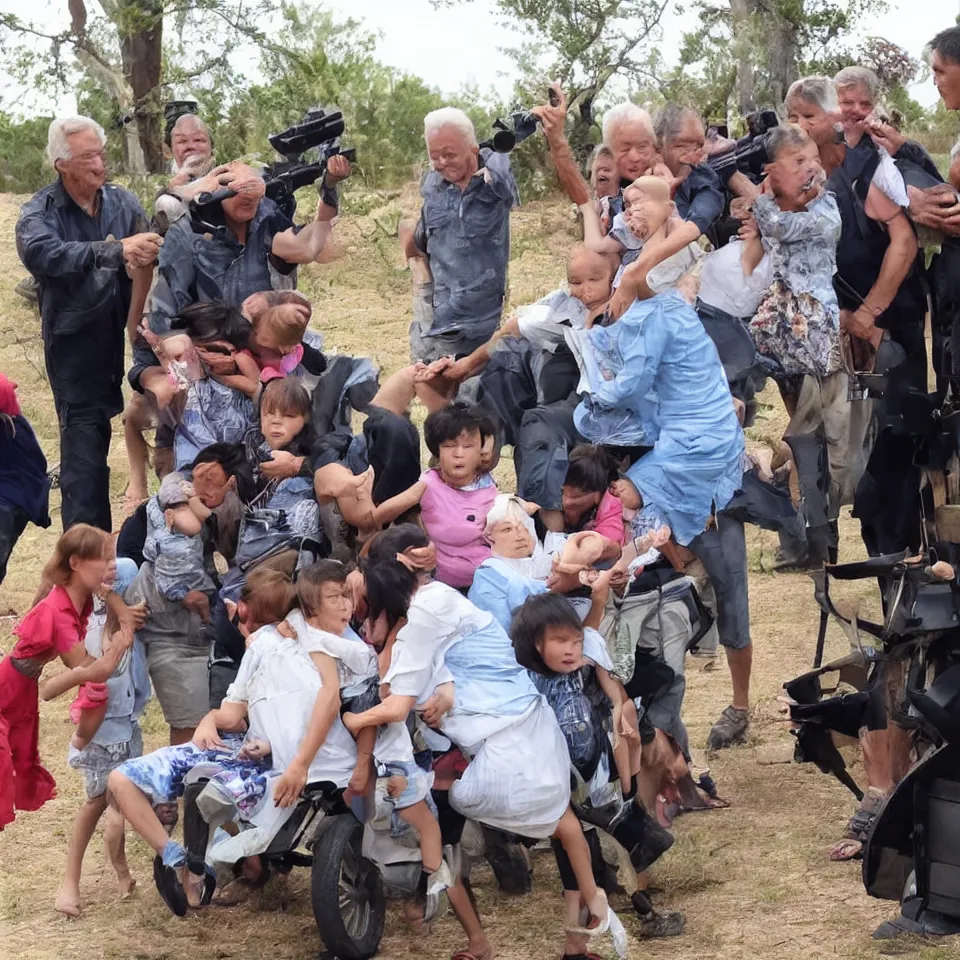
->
xmin=0 ymin=20 xmax=960 ymax=960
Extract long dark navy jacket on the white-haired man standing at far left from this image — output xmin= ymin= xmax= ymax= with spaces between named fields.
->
xmin=16 ymin=179 xmax=147 ymax=413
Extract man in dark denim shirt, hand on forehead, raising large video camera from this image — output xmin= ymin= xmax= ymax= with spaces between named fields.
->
xmin=128 ymin=156 xmax=350 ymax=407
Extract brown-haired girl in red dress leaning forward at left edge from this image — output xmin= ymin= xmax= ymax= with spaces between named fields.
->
xmin=0 ymin=523 xmax=132 ymax=829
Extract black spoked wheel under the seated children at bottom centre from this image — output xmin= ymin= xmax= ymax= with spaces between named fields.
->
xmin=310 ymin=813 xmax=386 ymax=960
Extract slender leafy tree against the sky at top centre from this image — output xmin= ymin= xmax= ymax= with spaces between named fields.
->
xmin=441 ymin=0 xmax=670 ymax=160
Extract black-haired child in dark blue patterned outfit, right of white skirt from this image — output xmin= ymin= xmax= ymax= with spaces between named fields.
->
xmin=510 ymin=596 xmax=683 ymax=940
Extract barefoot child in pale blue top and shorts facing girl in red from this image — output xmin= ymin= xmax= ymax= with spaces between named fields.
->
xmin=55 ymin=537 xmax=150 ymax=917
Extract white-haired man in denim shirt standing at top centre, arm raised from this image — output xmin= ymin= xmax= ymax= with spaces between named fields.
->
xmin=400 ymin=107 xmax=520 ymax=362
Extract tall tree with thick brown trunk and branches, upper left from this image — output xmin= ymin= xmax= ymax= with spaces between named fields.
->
xmin=0 ymin=0 xmax=270 ymax=174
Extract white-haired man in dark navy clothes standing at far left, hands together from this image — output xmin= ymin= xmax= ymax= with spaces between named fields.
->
xmin=16 ymin=117 xmax=162 ymax=530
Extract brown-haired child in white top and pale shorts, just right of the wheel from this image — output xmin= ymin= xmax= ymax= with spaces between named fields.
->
xmin=287 ymin=560 xmax=453 ymax=923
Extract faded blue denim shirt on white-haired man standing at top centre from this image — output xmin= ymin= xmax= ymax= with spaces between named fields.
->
xmin=416 ymin=149 xmax=520 ymax=337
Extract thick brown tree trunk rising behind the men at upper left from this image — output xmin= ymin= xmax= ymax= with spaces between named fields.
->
xmin=116 ymin=0 xmax=164 ymax=173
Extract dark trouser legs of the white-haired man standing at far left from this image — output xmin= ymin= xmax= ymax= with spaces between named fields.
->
xmin=53 ymin=398 xmax=113 ymax=532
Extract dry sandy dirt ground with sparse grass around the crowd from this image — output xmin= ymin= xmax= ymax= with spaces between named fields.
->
xmin=0 ymin=190 xmax=960 ymax=960
